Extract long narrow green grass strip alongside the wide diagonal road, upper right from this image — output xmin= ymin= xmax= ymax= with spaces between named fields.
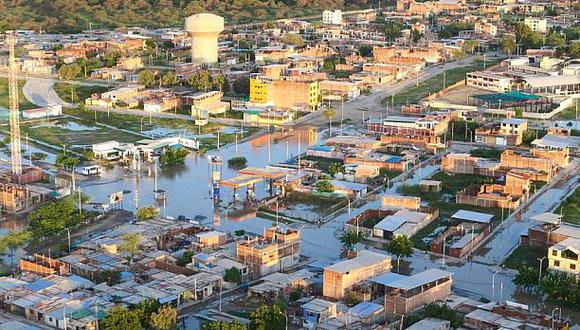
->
xmin=382 ymin=59 xmax=501 ymax=105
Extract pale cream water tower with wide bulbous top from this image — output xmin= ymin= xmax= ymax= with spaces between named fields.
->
xmin=185 ymin=13 xmax=224 ymax=63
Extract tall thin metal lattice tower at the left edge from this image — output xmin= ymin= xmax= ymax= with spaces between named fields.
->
xmin=6 ymin=33 xmax=22 ymax=177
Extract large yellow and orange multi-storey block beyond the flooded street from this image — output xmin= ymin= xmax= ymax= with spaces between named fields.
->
xmin=250 ymin=75 xmax=320 ymax=111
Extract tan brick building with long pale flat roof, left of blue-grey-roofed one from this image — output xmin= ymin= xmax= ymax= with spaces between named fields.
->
xmin=322 ymin=250 xmax=391 ymax=299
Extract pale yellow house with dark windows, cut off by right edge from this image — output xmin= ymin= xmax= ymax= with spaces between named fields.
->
xmin=548 ymin=237 xmax=580 ymax=278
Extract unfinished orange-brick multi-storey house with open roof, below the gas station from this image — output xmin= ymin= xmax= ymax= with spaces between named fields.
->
xmin=236 ymin=227 xmax=300 ymax=278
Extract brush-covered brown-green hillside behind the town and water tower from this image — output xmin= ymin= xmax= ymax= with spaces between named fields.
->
xmin=0 ymin=0 xmax=377 ymax=32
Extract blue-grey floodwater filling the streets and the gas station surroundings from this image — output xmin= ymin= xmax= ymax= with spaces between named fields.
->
xmin=35 ymin=130 xmax=574 ymax=324
